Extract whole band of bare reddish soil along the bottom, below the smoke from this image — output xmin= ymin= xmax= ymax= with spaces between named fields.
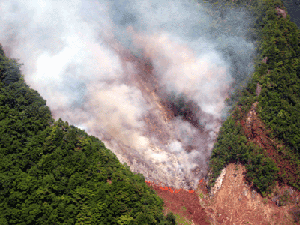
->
xmin=148 ymin=163 xmax=299 ymax=225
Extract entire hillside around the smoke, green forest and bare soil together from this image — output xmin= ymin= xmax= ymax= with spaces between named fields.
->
xmin=0 ymin=0 xmax=300 ymax=224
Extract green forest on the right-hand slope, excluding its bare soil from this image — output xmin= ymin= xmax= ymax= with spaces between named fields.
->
xmin=209 ymin=0 xmax=300 ymax=195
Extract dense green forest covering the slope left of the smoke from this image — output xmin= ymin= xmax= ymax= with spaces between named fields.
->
xmin=0 ymin=45 xmax=175 ymax=225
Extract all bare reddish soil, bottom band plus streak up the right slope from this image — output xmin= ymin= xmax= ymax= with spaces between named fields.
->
xmin=148 ymin=102 xmax=300 ymax=225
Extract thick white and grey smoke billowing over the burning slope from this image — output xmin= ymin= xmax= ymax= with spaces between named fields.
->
xmin=0 ymin=0 xmax=255 ymax=188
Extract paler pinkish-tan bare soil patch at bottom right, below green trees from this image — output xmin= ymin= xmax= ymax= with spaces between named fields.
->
xmin=196 ymin=164 xmax=295 ymax=225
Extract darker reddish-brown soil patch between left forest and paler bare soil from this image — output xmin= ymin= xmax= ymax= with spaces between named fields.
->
xmin=147 ymin=183 xmax=210 ymax=225
